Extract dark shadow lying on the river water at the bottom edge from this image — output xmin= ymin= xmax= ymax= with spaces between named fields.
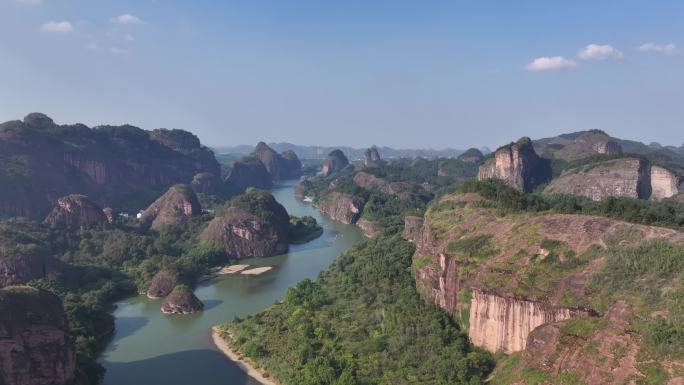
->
xmin=103 ymin=350 xmax=259 ymax=385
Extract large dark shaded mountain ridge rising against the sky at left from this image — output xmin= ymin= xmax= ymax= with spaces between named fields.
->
xmin=0 ymin=114 xmax=220 ymax=219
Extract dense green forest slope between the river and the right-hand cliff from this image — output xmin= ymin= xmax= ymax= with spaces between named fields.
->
xmin=225 ymin=235 xmax=494 ymax=385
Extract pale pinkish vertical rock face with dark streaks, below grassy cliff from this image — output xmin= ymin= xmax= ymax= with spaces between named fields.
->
xmin=468 ymin=290 xmax=586 ymax=353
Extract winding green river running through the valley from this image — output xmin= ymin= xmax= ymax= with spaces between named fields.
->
xmin=100 ymin=181 xmax=363 ymax=385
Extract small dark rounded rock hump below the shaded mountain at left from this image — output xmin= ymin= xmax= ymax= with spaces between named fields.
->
xmin=43 ymin=194 xmax=109 ymax=228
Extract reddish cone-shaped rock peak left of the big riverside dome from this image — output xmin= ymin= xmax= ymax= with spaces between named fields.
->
xmin=140 ymin=185 xmax=202 ymax=231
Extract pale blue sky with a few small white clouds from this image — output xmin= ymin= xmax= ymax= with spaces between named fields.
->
xmin=0 ymin=0 xmax=684 ymax=149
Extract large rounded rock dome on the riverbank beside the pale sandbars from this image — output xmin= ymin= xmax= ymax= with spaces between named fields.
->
xmin=199 ymin=189 xmax=290 ymax=258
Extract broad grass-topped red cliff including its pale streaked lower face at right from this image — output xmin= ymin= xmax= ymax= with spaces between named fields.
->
xmin=414 ymin=194 xmax=684 ymax=353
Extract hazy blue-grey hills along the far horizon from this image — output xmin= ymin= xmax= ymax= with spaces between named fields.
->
xmin=214 ymin=143 xmax=464 ymax=161
